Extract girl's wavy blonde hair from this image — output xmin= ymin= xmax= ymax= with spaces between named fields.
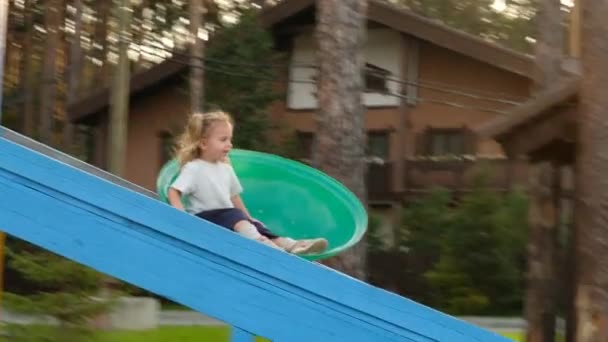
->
xmin=175 ymin=111 xmax=232 ymax=166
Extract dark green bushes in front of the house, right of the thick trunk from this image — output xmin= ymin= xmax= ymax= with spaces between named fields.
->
xmin=400 ymin=175 xmax=527 ymax=315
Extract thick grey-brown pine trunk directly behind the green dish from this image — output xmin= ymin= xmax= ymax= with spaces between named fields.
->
xmin=313 ymin=0 xmax=367 ymax=279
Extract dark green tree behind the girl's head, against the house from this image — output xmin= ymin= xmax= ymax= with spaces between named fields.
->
xmin=205 ymin=10 xmax=278 ymax=150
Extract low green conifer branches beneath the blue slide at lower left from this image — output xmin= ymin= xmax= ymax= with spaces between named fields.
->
xmin=5 ymin=248 xmax=112 ymax=342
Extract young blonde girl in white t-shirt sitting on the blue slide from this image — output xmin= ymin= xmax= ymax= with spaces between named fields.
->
xmin=168 ymin=111 xmax=327 ymax=254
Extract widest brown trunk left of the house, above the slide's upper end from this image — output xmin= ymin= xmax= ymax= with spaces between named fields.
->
xmin=39 ymin=0 xmax=63 ymax=144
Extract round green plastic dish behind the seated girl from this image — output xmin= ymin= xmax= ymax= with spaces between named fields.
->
xmin=157 ymin=149 xmax=367 ymax=260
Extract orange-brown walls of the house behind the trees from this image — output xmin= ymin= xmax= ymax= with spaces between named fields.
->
xmin=88 ymin=30 xmax=530 ymax=199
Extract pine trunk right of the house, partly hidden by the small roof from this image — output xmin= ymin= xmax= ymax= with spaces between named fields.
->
xmin=525 ymin=0 xmax=564 ymax=342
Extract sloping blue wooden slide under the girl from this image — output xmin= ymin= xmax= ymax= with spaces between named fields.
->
xmin=0 ymin=127 xmax=508 ymax=342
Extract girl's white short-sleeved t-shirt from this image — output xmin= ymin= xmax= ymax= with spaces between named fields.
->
xmin=171 ymin=159 xmax=243 ymax=214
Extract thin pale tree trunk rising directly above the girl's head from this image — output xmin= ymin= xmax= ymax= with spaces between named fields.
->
xmin=189 ymin=0 xmax=204 ymax=113
